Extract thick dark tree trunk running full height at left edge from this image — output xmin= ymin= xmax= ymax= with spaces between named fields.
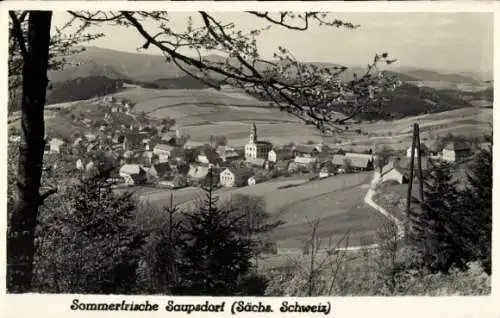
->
xmin=7 ymin=11 xmax=52 ymax=293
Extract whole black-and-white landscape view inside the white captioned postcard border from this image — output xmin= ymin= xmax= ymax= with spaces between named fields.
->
xmin=3 ymin=1 xmax=494 ymax=300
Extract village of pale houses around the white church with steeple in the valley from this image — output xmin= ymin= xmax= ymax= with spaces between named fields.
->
xmin=9 ymin=96 xmax=484 ymax=194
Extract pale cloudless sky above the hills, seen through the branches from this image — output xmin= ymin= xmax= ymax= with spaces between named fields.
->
xmin=53 ymin=12 xmax=493 ymax=73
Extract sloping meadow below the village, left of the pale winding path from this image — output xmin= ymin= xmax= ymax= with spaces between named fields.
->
xmin=135 ymin=173 xmax=385 ymax=251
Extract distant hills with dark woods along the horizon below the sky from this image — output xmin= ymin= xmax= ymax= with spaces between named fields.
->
xmin=9 ymin=47 xmax=492 ymax=119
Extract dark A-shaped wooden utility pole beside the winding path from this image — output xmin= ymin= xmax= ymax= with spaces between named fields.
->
xmin=405 ymin=124 xmax=424 ymax=240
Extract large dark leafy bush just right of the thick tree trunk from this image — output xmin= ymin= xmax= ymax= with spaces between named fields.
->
xmin=34 ymin=174 xmax=146 ymax=294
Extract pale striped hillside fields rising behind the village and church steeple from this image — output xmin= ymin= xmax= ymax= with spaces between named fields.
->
xmin=111 ymin=88 xmax=321 ymax=146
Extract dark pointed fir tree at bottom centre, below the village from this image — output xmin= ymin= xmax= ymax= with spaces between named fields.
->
xmin=172 ymin=171 xmax=260 ymax=296
